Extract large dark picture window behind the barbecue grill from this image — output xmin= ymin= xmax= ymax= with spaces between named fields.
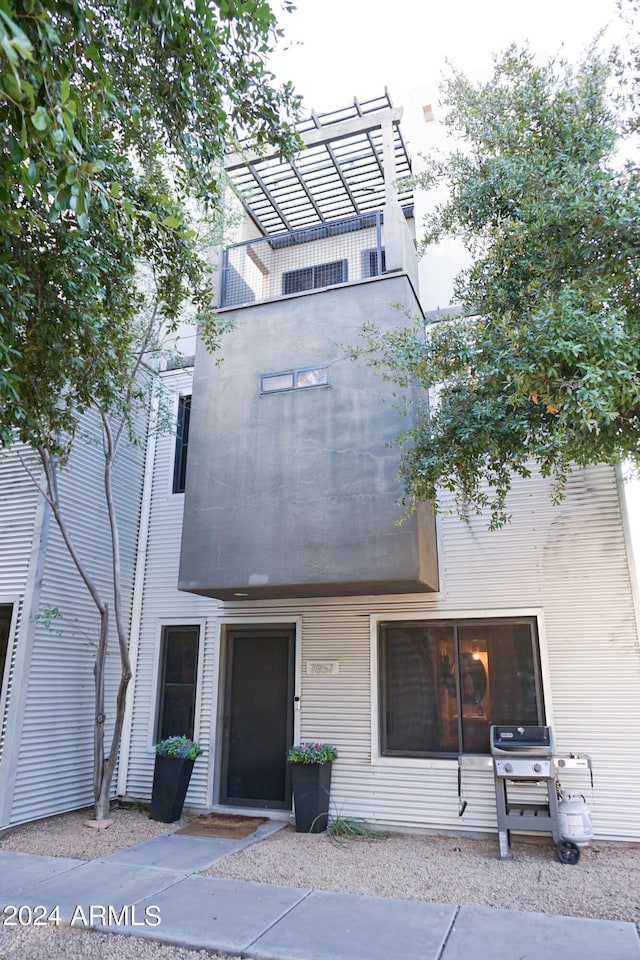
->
xmin=379 ymin=619 xmax=544 ymax=757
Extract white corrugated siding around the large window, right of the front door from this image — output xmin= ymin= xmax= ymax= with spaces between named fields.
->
xmin=225 ymin=467 xmax=640 ymax=840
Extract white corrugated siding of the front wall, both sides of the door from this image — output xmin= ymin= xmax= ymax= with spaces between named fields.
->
xmin=127 ymin=386 xmax=640 ymax=840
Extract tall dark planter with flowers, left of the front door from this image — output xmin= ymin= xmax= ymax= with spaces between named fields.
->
xmin=149 ymin=736 xmax=202 ymax=823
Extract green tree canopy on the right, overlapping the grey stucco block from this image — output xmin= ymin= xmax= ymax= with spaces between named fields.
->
xmin=358 ymin=41 xmax=640 ymax=526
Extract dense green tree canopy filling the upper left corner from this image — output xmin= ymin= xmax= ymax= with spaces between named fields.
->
xmin=0 ymin=0 xmax=298 ymax=448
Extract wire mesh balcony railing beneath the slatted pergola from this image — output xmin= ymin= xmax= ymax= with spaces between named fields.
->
xmin=220 ymin=211 xmax=385 ymax=307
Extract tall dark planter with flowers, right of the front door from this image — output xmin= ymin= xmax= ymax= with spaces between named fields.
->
xmin=287 ymin=743 xmax=338 ymax=833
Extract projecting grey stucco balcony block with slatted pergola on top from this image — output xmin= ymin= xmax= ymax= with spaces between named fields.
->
xmin=179 ymin=92 xmax=438 ymax=602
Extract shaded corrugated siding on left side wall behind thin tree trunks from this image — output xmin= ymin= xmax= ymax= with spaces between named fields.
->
xmin=6 ymin=406 xmax=144 ymax=823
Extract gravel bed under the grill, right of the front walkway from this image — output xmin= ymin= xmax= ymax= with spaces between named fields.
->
xmin=206 ymin=828 xmax=640 ymax=922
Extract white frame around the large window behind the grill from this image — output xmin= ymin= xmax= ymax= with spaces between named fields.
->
xmin=369 ymin=607 xmax=553 ymax=769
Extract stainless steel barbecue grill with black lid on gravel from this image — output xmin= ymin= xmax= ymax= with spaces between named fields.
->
xmin=490 ymin=724 xmax=591 ymax=864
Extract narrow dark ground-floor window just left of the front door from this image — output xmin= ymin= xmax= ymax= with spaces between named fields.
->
xmin=157 ymin=625 xmax=200 ymax=740
